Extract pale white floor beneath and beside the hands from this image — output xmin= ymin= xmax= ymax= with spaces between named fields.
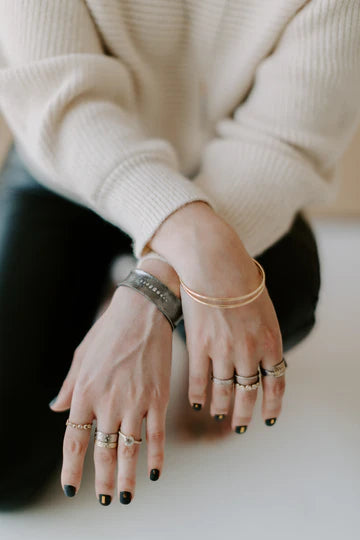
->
xmin=0 ymin=219 xmax=360 ymax=540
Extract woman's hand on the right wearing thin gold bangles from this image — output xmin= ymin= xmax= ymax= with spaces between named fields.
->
xmin=150 ymin=202 xmax=285 ymax=433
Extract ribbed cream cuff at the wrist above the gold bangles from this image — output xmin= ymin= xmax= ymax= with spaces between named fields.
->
xmin=96 ymin=154 xmax=216 ymax=258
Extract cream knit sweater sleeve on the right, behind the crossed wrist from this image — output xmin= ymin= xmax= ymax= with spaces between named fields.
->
xmin=194 ymin=0 xmax=360 ymax=257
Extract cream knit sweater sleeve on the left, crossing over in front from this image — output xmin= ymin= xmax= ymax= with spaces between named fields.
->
xmin=0 ymin=0 xmax=214 ymax=257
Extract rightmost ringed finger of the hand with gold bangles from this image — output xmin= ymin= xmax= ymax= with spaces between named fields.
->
xmin=261 ymin=357 xmax=285 ymax=426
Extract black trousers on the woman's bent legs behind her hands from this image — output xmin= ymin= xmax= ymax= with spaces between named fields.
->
xmin=0 ymin=147 xmax=320 ymax=510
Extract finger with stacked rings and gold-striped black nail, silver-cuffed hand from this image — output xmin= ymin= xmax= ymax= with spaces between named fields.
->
xmin=94 ymin=413 xmax=120 ymax=506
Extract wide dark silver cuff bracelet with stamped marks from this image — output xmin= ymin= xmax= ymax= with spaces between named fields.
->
xmin=117 ymin=268 xmax=183 ymax=330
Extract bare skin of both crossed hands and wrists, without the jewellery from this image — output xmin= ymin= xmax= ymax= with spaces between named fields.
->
xmin=52 ymin=202 xmax=285 ymax=502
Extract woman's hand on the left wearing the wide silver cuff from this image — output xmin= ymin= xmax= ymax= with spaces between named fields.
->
xmin=52 ymin=260 xmax=179 ymax=504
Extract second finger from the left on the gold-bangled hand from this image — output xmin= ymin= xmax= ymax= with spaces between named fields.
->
xmin=210 ymin=359 xmax=234 ymax=421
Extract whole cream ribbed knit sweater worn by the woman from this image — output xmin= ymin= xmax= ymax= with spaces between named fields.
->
xmin=0 ymin=0 xmax=360 ymax=257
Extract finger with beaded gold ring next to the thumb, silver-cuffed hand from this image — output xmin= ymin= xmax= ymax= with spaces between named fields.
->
xmin=61 ymin=392 xmax=94 ymax=497
